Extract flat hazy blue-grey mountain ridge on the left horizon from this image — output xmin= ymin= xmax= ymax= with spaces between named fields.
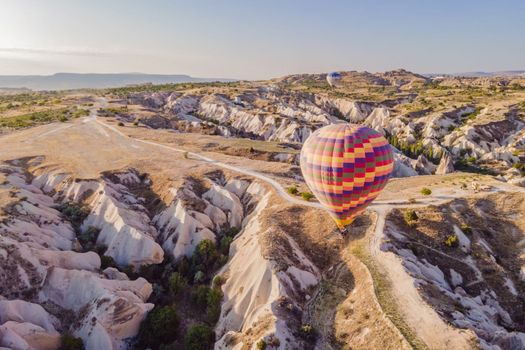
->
xmin=0 ymin=73 xmax=235 ymax=90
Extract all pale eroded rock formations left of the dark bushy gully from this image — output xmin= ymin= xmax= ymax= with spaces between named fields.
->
xmin=0 ymin=158 xmax=262 ymax=349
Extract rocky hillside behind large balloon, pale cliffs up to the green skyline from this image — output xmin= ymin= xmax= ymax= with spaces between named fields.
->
xmin=103 ymin=70 xmax=525 ymax=182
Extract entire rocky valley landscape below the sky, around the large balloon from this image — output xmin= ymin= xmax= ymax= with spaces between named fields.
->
xmin=0 ymin=70 xmax=525 ymax=349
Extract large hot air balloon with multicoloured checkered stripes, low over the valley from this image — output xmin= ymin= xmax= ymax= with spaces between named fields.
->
xmin=301 ymin=123 xmax=393 ymax=230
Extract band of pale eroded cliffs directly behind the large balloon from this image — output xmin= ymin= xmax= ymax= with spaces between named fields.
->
xmin=128 ymin=82 xmax=525 ymax=180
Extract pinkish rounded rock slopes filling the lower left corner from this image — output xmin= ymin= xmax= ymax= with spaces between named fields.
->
xmin=0 ymin=163 xmax=153 ymax=349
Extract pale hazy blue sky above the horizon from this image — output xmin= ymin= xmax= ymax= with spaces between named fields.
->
xmin=0 ymin=0 xmax=525 ymax=79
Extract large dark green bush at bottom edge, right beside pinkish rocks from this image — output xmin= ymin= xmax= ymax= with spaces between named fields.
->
xmin=138 ymin=305 xmax=179 ymax=348
